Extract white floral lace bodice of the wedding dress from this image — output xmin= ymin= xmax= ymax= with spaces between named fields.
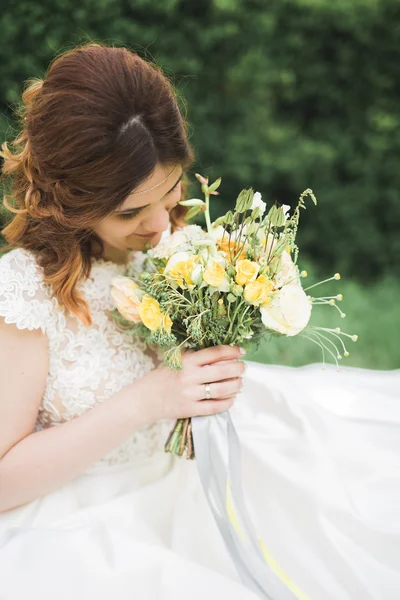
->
xmin=0 ymin=248 xmax=174 ymax=466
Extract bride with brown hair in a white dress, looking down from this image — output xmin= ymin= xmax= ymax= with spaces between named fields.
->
xmin=0 ymin=43 xmax=400 ymax=600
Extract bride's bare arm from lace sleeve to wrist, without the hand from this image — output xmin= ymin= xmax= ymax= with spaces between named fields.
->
xmin=0 ymin=319 xmax=159 ymax=512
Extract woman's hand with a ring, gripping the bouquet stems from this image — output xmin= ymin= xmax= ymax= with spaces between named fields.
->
xmin=136 ymin=346 xmax=246 ymax=422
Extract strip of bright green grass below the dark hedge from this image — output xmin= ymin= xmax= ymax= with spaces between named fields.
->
xmin=246 ymin=269 xmax=400 ymax=370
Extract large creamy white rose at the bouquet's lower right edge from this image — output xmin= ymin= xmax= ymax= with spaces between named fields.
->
xmin=260 ymin=285 xmax=311 ymax=336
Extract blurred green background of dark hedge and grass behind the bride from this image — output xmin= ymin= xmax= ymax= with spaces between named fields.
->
xmin=0 ymin=0 xmax=400 ymax=368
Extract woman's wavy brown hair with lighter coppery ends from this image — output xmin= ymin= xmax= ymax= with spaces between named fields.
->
xmin=0 ymin=42 xmax=194 ymax=325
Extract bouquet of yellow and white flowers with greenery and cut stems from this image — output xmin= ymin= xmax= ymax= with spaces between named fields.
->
xmin=111 ymin=174 xmax=357 ymax=459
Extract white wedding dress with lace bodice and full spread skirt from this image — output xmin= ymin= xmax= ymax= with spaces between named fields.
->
xmin=0 ymin=249 xmax=400 ymax=600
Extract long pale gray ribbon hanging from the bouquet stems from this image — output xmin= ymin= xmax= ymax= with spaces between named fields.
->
xmin=192 ymin=412 xmax=296 ymax=600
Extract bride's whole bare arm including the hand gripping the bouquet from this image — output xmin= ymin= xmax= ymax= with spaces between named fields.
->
xmin=0 ymin=321 xmax=244 ymax=512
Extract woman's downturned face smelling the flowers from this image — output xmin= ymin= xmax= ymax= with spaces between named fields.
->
xmin=93 ymin=164 xmax=183 ymax=262
